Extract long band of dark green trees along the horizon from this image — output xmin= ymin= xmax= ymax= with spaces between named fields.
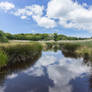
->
xmin=0 ymin=30 xmax=86 ymax=42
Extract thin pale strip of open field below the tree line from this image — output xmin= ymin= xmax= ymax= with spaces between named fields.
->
xmin=6 ymin=39 xmax=92 ymax=46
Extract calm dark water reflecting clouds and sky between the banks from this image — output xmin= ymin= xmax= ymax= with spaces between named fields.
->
xmin=0 ymin=50 xmax=92 ymax=92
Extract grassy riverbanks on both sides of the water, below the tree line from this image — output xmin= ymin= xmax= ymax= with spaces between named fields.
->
xmin=0 ymin=40 xmax=92 ymax=67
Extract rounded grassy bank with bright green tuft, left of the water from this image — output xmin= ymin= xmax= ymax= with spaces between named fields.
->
xmin=0 ymin=42 xmax=42 ymax=67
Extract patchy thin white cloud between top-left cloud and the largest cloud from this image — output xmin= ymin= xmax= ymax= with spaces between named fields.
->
xmin=13 ymin=5 xmax=44 ymax=19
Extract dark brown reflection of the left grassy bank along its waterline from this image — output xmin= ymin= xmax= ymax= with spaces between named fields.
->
xmin=0 ymin=51 xmax=42 ymax=85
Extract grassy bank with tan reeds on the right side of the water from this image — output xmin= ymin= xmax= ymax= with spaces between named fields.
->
xmin=42 ymin=40 xmax=92 ymax=61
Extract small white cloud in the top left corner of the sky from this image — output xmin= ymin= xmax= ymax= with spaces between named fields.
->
xmin=0 ymin=2 xmax=15 ymax=12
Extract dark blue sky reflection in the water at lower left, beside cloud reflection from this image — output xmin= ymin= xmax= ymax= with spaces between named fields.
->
xmin=4 ymin=67 xmax=54 ymax=92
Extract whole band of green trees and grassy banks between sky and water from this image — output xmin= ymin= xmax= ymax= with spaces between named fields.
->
xmin=0 ymin=31 xmax=92 ymax=67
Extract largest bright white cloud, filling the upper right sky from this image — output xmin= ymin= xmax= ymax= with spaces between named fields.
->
xmin=47 ymin=0 xmax=92 ymax=32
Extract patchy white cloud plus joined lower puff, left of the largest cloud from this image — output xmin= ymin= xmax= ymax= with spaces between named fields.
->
xmin=14 ymin=5 xmax=56 ymax=28
